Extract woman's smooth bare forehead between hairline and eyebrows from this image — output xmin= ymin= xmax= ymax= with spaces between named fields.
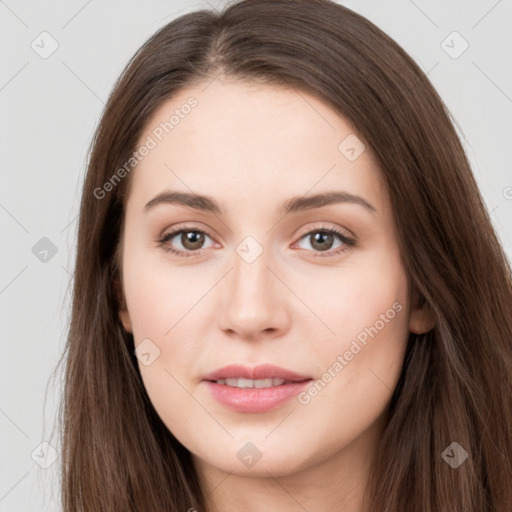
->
xmin=126 ymin=79 xmax=382 ymax=216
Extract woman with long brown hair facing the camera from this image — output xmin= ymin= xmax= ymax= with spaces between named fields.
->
xmin=56 ymin=0 xmax=512 ymax=512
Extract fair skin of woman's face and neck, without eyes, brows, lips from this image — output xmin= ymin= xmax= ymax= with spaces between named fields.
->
xmin=118 ymin=77 xmax=433 ymax=512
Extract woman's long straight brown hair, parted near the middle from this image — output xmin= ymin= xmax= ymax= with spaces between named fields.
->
xmin=52 ymin=0 xmax=512 ymax=512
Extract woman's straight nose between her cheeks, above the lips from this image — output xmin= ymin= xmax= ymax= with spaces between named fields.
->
xmin=218 ymin=243 xmax=291 ymax=340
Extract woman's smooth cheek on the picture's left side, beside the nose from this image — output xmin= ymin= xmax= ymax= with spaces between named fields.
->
xmin=123 ymin=250 xmax=211 ymax=420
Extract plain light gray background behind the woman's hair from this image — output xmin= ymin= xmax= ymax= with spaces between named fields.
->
xmin=0 ymin=0 xmax=512 ymax=512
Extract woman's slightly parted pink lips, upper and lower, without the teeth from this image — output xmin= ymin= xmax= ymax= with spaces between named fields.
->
xmin=204 ymin=365 xmax=311 ymax=413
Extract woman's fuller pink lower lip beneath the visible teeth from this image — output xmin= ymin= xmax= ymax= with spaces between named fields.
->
xmin=205 ymin=379 xmax=311 ymax=412
